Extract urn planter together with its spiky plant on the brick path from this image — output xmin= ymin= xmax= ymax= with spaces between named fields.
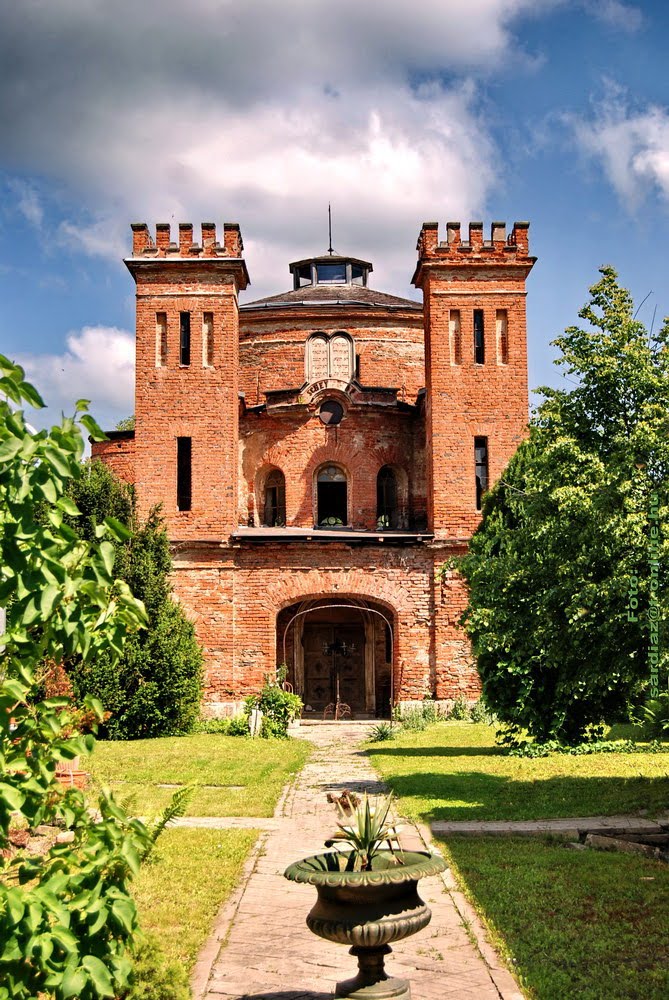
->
xmin=284 ymin=794 xmax=446 ymax=1000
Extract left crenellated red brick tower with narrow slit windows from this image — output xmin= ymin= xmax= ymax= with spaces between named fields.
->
xmin=125 ymin=222 xmax=249 ymax=540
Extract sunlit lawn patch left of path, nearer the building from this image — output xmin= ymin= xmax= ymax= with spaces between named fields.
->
xmin=84 ymin=734 xmax=310 ymax=816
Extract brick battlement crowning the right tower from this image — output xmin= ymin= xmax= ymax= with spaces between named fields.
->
xmin=416 ymin=222 xmax=534 ymax=264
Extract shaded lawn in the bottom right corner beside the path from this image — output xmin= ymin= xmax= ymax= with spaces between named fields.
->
xmin=438 ymin=837 xmax=669 ymax=1000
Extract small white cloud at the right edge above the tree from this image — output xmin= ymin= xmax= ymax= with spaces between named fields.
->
xmin=571 ymin=84 xmax=669 ymax=209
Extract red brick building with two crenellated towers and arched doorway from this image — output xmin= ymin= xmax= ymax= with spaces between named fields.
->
xmin=94 ymin=217 xmax=535 ymax=716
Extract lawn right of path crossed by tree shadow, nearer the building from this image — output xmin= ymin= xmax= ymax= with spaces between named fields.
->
xmin=366 ymin=722 xmax=669 ymax=822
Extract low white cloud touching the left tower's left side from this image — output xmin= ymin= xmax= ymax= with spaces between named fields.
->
xmin=15 ymin=326 xmax=135 ymax=428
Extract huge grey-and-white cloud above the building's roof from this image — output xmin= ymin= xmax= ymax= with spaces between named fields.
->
xmin=0 ymin=0 xmax=559 ymax=295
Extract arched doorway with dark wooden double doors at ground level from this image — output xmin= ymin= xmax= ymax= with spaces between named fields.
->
xmin=277 ymin=597 xmax=394 ymax=718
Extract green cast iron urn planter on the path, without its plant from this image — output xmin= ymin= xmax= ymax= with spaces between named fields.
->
xmin=284 ymin=851 xmax=446 ymax=1000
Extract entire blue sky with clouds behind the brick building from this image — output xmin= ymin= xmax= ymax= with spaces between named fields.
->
xmin=0 ymin=0 xmax=669 ymax=429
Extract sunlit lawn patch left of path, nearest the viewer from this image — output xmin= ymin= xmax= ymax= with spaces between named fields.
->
xmin=133 ymin=828 xmax=258 ymax=973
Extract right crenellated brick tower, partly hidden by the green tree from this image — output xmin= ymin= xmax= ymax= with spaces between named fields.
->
xmin=413 ymin=222 xmax=536 ymax=539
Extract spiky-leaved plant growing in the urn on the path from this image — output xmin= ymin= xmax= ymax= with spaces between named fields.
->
xmin=325 ymin=792 xmax=400 ymax=871
